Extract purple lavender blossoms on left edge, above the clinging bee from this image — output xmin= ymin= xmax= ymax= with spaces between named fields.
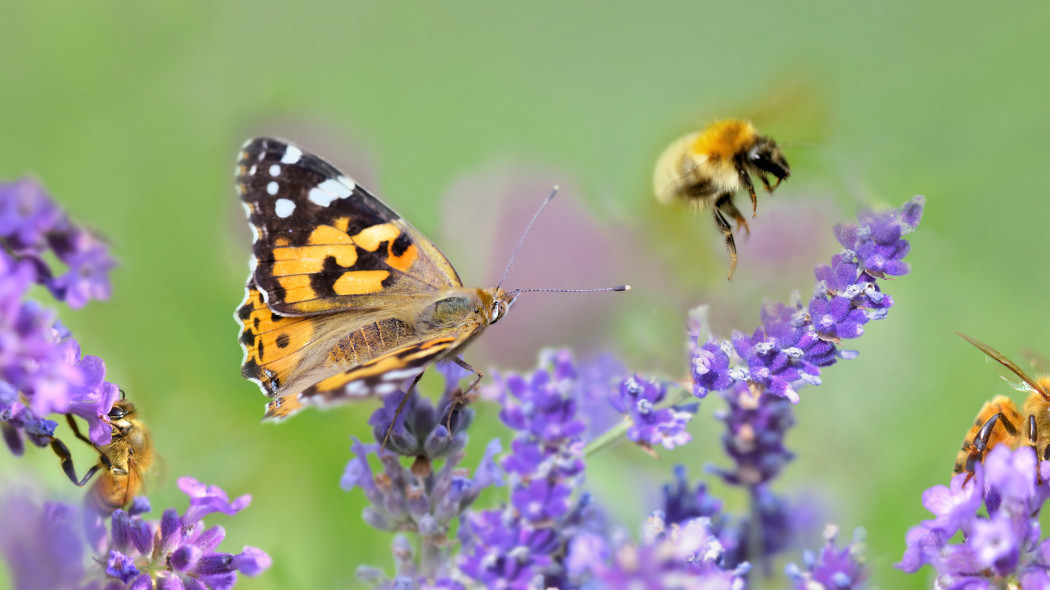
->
xmin=0 ymin=180 xmax=120 ymax=455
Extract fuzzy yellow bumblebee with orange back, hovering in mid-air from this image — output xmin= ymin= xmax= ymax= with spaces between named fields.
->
xmin=653 ymin=119 xmax=791 ymax=280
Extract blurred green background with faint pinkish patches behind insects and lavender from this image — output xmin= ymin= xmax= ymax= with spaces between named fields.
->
xmin=0 ymin=0 xmax=1050 ymax=589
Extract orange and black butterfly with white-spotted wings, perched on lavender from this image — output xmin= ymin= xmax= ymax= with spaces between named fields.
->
xmin=235 ymin=139 xmax=518 ymax=419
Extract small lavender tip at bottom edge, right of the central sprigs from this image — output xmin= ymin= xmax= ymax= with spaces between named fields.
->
xmin=784 ymin=525 xmax=870 ymax=590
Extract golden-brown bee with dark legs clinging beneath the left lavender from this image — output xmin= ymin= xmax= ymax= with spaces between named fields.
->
xmin=51 ymin=399 xmax=153 ymax=515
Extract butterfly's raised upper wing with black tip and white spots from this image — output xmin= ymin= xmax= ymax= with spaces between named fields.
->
xmin=237 ymin=138 xmax=462 ymax=316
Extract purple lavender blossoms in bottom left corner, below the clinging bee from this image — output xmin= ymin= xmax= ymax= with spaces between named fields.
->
xmin=0 ymin=478 xmax=271 ymax=590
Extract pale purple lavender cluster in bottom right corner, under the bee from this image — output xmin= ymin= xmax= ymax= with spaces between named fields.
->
xmin=897 ymin=445 xmax=1050 ymax=589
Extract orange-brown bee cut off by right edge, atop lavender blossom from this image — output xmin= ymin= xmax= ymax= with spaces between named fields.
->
xmin=952 ymin=334 xmax=1050 ymax=475
